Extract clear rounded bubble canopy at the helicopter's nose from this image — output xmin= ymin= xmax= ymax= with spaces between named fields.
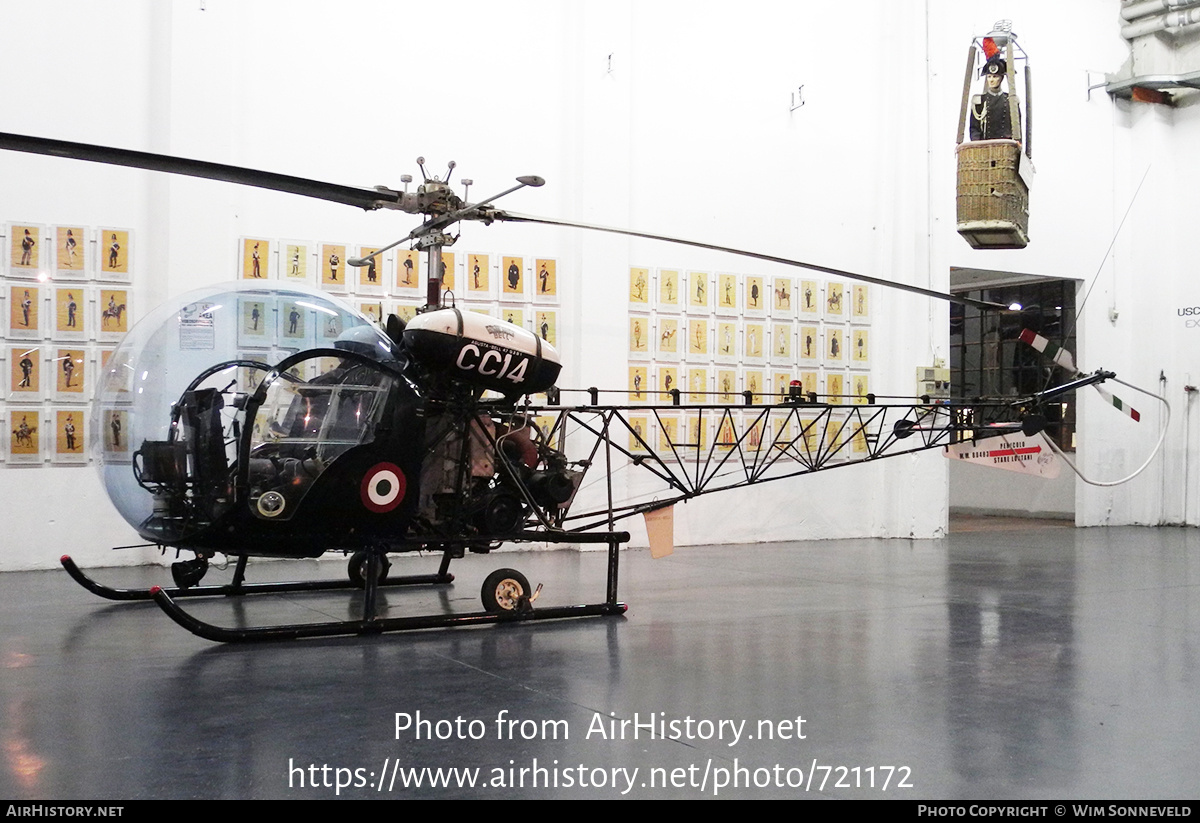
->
xmin=91 ymin=283 xmax=394 ymax=529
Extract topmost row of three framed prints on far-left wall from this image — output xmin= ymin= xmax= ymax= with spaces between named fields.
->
xmin=2 ymin=222 xmax=133 ymax=283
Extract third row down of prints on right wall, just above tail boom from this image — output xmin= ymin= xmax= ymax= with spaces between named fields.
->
xmin=625 ymin=362 xmax=871 ymax=406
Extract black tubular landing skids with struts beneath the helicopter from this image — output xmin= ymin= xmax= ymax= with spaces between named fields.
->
xmin=61 ymin=531 xmax=629 ymax=643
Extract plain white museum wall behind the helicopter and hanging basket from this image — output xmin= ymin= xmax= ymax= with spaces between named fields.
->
xmin=0 ymin=0 xmax=1200 ymax=569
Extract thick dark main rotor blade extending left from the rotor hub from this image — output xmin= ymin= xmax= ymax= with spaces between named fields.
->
xmin=0 ymin=132 xmax=400 ymax=211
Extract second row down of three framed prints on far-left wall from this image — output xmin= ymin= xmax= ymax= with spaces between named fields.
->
xmin=0 ymin=280 xmax=133 ymax=342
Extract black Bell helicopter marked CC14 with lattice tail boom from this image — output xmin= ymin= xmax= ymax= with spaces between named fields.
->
xmin=0 ymin=133 xmax=1142 ymax=642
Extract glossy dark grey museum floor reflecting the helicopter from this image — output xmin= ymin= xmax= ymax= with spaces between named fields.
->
xmin=0 ymin=519 xmax=1200 ymax=799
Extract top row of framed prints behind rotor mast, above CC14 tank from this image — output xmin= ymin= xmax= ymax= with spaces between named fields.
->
xmin=236 ymin=238 xmax=559 ymax=304
